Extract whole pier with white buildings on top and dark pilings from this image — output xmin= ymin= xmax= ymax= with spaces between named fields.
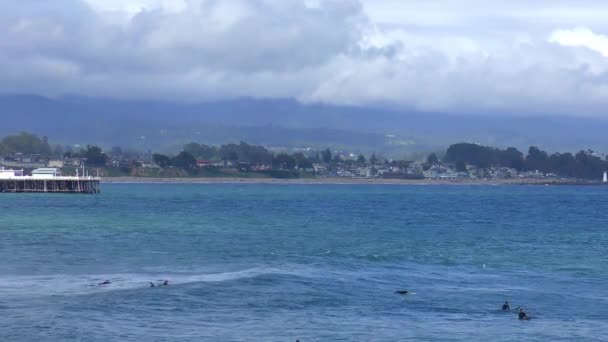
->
xmin=0 ymin=168 xmax=101 ymax=194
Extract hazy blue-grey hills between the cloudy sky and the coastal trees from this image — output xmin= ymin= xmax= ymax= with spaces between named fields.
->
xmin=0 ymin=95 xmax=608 ymax=155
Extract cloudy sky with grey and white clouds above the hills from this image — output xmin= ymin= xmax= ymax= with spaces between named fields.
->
xmin=0 ymin=0 xmax=608 ymax=117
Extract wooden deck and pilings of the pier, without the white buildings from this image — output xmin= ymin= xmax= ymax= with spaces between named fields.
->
xmin=0 ymin=176 xmax=101 ymax=194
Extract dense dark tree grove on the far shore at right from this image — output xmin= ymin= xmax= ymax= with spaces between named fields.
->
xmin=444 ymin=143 xmax=608 ymax=179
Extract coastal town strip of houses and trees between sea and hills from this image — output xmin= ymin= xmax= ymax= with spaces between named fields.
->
xmin=0 ymin=135 xmax=608 ymax=182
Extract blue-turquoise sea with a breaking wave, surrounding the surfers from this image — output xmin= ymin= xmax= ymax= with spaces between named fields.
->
xmin=0 ymin=184 xmax=608 ymax=341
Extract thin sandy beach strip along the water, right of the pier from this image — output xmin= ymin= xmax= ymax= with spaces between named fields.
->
xmin=101 ymin=177 xmax=604 ymax=186
